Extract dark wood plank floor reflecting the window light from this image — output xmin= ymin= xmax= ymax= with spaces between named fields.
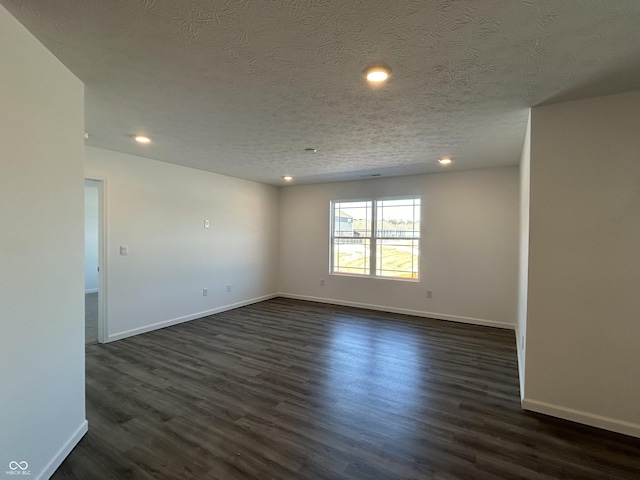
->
xmin=53 ymin=298 xmax=640 ymax=480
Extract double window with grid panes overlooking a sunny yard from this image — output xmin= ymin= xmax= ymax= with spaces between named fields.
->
xmin=330 ymin=197 xmax=420 ymax=280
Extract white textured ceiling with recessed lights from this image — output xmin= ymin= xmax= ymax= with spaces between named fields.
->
xmin=0 ymin=0 xmax=640 ymax=185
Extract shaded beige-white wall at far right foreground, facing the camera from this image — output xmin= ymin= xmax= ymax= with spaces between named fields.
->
xmin=523 ymin=91 xmax=640 ymax=436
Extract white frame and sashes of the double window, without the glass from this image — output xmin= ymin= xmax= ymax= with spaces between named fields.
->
xmin=329 ymin=195 xmax=422 ymax=282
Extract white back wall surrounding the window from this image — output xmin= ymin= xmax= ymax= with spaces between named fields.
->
xmin=280 ymin=167 xmax=519 ymax=328
